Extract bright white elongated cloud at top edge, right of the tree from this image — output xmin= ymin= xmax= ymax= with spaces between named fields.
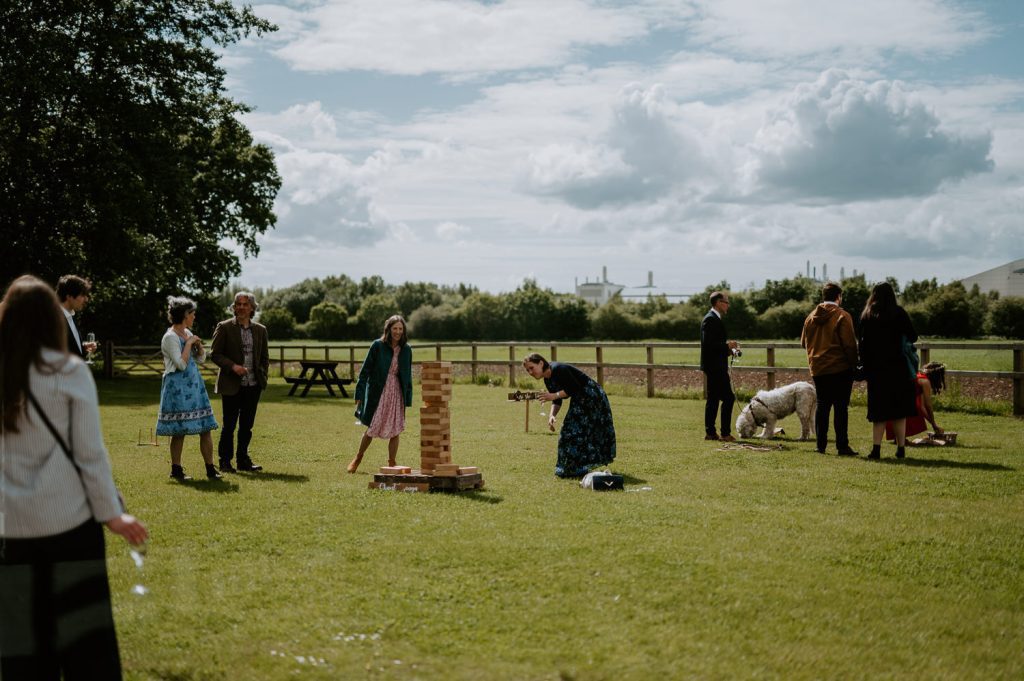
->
xmin=264 ymin=0 xmax=647 ymax=75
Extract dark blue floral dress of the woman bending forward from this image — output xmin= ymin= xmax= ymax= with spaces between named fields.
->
xmin=555 ymin=380 xmax=615 ymax=477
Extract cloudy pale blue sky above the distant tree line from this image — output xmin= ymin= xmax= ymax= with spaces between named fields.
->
xmin=223 ymin=0 xmax=1024 ymax=293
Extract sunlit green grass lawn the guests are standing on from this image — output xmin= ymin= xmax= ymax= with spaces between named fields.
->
xmin=100 ymin=378 xmax=1024 ymax=680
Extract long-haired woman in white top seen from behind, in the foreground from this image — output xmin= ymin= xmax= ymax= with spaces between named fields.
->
xmin=0 ymin=276 xmax=147 ymax=681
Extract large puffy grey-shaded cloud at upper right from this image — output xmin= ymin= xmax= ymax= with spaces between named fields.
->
xmin=754 ymin=70 xmax=993 ymax=202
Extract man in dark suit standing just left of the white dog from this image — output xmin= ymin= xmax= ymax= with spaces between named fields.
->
xmin=700 ymin=291 xmax=739 ymax=442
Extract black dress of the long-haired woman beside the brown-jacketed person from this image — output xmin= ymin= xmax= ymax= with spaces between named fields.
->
xmin=859 ymin=307 xmax=918 ymax=423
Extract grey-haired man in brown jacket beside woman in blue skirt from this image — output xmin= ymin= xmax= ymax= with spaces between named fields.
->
xmin=210 ymin=291 xmax=270 ymax=473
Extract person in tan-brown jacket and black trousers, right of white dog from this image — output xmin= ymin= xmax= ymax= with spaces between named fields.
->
xmin=800 ymin=282 xmax=857 ymax=457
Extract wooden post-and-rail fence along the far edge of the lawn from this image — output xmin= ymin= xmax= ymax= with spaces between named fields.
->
xmin=103 ymin=341 xmax=1024 ymax=416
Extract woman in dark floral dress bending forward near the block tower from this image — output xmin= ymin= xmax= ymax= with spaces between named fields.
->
xmin=522 ymin=352 xmax=615 ymax=477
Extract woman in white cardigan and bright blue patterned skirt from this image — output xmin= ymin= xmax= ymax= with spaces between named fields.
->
xmin=157 ymin=296 xmax=220 ymax=480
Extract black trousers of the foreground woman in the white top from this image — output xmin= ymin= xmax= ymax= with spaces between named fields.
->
xmin=0 ymin=520 xmax=121 ymax=681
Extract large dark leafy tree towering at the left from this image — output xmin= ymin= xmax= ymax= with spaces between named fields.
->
xmin=0 ymin=0 xmax=281 ymax=340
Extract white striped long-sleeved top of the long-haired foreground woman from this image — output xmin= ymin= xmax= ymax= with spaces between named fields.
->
xmin=0 ymin=349 xmax=121 ymax=539
